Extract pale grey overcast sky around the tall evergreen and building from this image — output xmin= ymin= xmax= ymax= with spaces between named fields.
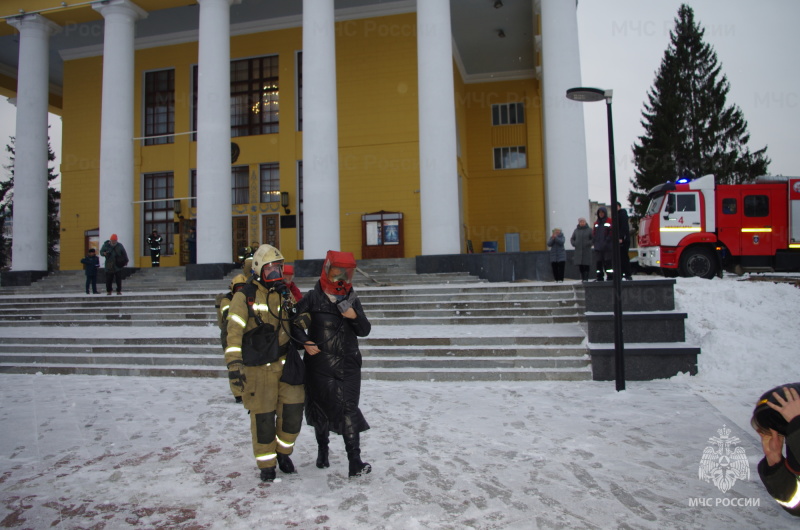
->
xmin=0 ymin=0 xmax=800 ymax=202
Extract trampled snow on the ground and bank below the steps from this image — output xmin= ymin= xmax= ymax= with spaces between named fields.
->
xmin=0 ymin=277 xmax=800 ymax=529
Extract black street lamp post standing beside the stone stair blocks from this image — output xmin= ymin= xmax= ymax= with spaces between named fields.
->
xmin=567 ymin=87 xmax=625 ymax=391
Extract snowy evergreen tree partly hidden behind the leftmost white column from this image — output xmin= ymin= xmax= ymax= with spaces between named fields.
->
xmin=0 ymin=136 xmax=61 ymax=271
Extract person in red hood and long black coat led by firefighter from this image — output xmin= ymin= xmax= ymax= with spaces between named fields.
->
xmin=292 ymin=250 xmax=372 ymax=477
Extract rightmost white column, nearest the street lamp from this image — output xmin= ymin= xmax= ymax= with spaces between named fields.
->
xmin=537 ymin=0 xmax=588 ymax=239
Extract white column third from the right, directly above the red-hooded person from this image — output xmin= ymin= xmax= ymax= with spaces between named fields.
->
xmin=303 ymin=0 xmax=341 ymax=259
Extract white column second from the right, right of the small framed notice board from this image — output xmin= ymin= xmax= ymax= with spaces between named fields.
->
xmin=417 ymin=0 xmax=461 ymax=255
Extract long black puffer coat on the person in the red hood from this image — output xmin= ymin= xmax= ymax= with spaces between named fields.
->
xmin=292 ymin=282 xmax=372 ymax=435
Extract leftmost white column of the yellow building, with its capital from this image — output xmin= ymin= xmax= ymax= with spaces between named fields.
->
xmin=8 ymin=15 xmax=60 ymax=271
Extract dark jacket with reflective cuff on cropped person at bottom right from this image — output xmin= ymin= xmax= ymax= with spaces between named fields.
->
xmin=758 ymin=416 xmax=800 ymax=516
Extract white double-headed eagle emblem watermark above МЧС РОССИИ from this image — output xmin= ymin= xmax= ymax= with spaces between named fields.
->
xmin=699 ymin=425 xmax=750 ymax=493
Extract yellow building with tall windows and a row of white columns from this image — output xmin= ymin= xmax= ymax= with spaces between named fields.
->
xmin=0 ymin=0 xmax=588 ymax=278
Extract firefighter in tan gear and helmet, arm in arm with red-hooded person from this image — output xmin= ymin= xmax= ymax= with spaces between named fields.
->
xmin=225 ymin=241 xmax=305 ymax=482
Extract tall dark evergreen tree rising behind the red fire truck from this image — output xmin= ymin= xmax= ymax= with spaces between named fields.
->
xmin=628 ymin=4 xmax=770 ymax=216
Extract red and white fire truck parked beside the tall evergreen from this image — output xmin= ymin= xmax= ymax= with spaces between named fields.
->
xmin=638 ymin=175 xmax=800 ymax=278
